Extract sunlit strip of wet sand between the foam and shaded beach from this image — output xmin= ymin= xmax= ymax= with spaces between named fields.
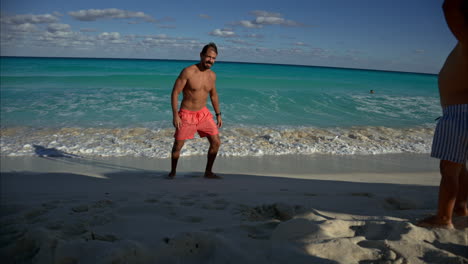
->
xmin=0 ymin=153 xmax=440 ymax=182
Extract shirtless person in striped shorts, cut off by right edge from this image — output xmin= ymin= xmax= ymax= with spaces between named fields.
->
xmin=417 ymin=0 xmax=468 ymax=228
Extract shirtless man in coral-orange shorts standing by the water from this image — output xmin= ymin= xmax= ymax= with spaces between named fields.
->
xmin=168 ymin=43 xmax=223 ymax=179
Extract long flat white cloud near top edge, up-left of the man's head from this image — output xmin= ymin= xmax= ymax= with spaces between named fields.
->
xmin=68 ymin=8 xmax=157 ymax=22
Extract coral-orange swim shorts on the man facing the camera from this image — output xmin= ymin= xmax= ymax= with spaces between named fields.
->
xmin=174 ymin=106 xmax=219 ymax=140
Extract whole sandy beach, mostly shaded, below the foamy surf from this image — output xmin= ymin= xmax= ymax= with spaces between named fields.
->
xmin=0 ymin=155 xmax=468 ymax=264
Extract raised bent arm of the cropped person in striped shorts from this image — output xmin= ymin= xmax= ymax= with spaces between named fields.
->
xmin=442 ymin=0 xmax=468 ymax=43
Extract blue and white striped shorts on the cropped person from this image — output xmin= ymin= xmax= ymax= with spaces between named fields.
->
xmin=431 ymin=104 xmax=468 ymax=164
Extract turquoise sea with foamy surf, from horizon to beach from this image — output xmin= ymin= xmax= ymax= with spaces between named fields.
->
xmin=0 ymin=57 xmax=441 ymax=158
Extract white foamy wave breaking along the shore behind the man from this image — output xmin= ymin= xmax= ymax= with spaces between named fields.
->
xmin=0 ymin=127 xmax=434 ymax=158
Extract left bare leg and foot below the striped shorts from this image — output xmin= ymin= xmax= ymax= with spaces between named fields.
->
xmin=417 ymin=160 xmax=463 ymax=228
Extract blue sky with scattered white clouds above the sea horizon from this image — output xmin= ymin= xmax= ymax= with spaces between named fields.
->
xmin=0 ymin=0 xmax=456 ymax=73
